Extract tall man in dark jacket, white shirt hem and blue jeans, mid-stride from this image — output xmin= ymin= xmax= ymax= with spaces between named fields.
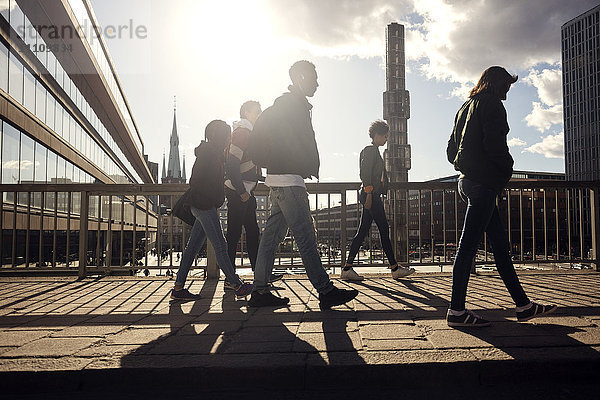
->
xmin=248 ymin=61 xmax=358 ymax=309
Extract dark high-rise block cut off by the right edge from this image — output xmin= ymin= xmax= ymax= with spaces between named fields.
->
xmin=561 ymin=5 xmax=600 ymax=181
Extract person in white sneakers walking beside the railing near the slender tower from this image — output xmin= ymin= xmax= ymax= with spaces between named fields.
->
xmin=340 ymin=121 xmax=415 ymax=281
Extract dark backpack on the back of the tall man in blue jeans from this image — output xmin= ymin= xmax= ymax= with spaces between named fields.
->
xmin=246 ymin=106 xmax=279 ymax=168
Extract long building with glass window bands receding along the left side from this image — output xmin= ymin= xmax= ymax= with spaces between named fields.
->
xmin=0 ymin=0 xmax=154 ymax=265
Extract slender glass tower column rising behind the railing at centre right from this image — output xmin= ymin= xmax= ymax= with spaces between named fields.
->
xmin=383 ymin=23 xmax=410 ymax=261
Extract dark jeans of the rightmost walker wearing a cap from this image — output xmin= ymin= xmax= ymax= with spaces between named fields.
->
xmin=450 ymin=178 xmax=529 ymax=311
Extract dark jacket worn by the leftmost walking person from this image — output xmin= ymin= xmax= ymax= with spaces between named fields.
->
xmin=186 ymin=141 xmax=225 ymax=210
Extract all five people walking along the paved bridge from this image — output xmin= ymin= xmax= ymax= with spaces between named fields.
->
xmin=171 ymin=60 xmax=556 ymax=327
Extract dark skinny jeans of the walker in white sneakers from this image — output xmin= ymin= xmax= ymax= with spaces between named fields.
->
xmin=346 ymin=191 xmax=396 ymax=265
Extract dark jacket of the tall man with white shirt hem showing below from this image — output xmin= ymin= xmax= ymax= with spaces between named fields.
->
xmin=253 ymin=86 xmax=320 ymax=178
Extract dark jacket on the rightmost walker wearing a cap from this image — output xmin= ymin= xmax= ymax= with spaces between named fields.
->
xmin=446 ymin=93 xmax=514 ymax=192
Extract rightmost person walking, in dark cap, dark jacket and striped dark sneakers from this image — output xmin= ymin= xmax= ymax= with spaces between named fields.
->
xmin=446 ymin=67 xmax=556 ymax=327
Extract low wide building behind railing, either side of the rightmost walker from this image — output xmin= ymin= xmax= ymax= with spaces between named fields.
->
xmin=408 ymin=171 xmax=569 ymax=260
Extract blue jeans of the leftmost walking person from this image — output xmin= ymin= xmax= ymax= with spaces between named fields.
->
xmin=175 ymin=207 xmax=242 ymax=286
